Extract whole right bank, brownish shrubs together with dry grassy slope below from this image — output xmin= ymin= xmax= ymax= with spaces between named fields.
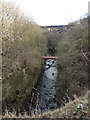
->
xmin=43 ymin=18 xmax=89 ymax=119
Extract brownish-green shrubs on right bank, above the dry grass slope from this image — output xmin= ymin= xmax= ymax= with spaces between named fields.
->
xmin=56 ymin=18 xmax=89 ymax=105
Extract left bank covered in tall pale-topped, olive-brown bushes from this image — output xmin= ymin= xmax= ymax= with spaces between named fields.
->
xmin=0 ymin=2 xmax=47 ymax=110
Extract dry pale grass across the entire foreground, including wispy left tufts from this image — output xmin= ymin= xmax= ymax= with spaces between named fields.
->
xmin=3 ymin=91 xmax=90 ymax=119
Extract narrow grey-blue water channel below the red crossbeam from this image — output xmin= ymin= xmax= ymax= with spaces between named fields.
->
xmin=34 ymin=56 xmax=58 ymax=112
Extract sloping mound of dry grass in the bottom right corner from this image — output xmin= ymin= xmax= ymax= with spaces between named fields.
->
xmin=43 ymin=91 xmax=89 ymax=118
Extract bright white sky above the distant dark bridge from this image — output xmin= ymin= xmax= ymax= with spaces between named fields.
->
xmin=6 ymin=0 xmax=89 ymax=25
